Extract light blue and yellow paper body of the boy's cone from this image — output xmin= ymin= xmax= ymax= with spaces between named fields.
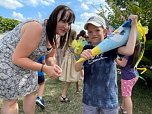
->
xmin=77 ymin=21 xmax=131 ymax=62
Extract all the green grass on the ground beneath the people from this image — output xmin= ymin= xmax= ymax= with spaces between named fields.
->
xmin=0 ymin=76 xmax=152 ymax=114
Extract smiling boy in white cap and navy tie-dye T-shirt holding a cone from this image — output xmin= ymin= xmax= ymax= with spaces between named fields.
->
xmin=75 ymin=15 xmax=137 ymax=114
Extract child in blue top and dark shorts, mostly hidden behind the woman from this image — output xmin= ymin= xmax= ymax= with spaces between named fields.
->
xmin=36 ymin=55 xmax=45 ymax=109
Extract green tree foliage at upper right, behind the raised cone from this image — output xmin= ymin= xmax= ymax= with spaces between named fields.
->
xmin=99 ymin=0 xmax=152 ymax=65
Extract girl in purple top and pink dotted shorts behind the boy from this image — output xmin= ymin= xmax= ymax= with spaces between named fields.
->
xmin=116 ymin=42 xmax=141 ymax=114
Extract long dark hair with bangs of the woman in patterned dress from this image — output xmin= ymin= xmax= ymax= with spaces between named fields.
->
xmin=46 ymin=5 xmax=75 ymax=48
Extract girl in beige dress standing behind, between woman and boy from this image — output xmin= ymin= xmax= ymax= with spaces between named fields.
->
xmin=59 ymin=30 xmax=80 ymax=102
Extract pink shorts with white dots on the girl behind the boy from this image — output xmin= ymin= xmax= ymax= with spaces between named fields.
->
xmin=121 ymin=77 xmax=138 ymax=97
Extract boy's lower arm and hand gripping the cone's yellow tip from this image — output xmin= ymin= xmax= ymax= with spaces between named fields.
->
xmin=75 ymin=49 xmax=93 ymax=72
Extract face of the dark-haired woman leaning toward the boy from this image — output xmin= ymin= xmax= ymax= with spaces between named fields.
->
xmin=56 ymin=11 xmax=71 ymax=36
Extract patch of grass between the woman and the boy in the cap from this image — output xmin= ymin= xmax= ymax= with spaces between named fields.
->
xmin=33 ymin=79 xmax=82 ymax=114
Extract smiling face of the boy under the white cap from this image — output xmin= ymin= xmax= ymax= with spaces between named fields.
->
xmin=87 ymin=24 xmax=105 ymax=46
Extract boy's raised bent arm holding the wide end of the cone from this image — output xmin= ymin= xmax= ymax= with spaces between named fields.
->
xmin=118 ymin=15 xmax=138 ymax=56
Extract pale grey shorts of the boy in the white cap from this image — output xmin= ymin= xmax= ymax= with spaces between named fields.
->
xmin=83 ymin=103 xmax=118 ymax=114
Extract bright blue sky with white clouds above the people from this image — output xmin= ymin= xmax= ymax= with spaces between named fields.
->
xmin=0 ymin=0 xmax=106 ymax=32
